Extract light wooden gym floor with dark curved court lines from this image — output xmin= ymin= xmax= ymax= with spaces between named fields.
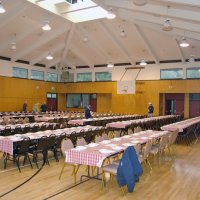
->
xmin=0 ymin=141 xmax=200 ymax=200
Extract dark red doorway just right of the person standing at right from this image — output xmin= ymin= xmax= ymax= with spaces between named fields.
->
xmin=165 ymin=94 xmax=184 ymax=115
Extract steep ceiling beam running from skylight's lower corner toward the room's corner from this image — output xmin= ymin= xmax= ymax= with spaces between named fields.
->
xmin=60 ymin=23 xmax=75 ymax=67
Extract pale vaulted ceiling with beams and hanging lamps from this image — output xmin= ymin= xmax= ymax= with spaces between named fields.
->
xmin=0 ymin=0 xmax=200 ymax=68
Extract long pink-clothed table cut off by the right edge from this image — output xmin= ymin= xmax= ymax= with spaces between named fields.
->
xmin=161 ymin=116 xmax=200 ymax=132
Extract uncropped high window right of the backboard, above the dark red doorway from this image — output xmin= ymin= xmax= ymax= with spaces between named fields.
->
xmin=160 ymin=69 xmax=183 ymax=79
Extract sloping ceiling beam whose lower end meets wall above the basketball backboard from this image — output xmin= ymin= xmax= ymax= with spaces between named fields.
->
xmin=97 ymin=22 xmax=136 ymax=65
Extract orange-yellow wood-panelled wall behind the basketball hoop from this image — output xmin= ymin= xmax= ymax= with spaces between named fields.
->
xmin=0 ymin=77 xmax=200 ymax=117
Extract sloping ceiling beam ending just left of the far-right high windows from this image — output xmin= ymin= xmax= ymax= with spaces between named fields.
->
xmin=131 ymin=23 xmax=160 ymax=64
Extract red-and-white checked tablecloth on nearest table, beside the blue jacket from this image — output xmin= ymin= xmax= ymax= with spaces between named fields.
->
xmin=65 ymin=130 xmax=169 ymax=167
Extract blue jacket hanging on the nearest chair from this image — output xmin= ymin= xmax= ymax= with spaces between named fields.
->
xmin=117 ymin=146 xmax=142 ymax=192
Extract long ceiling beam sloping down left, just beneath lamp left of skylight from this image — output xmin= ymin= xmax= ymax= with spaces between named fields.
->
xmin=11 ymin=28 xmax=66 ymax=61
